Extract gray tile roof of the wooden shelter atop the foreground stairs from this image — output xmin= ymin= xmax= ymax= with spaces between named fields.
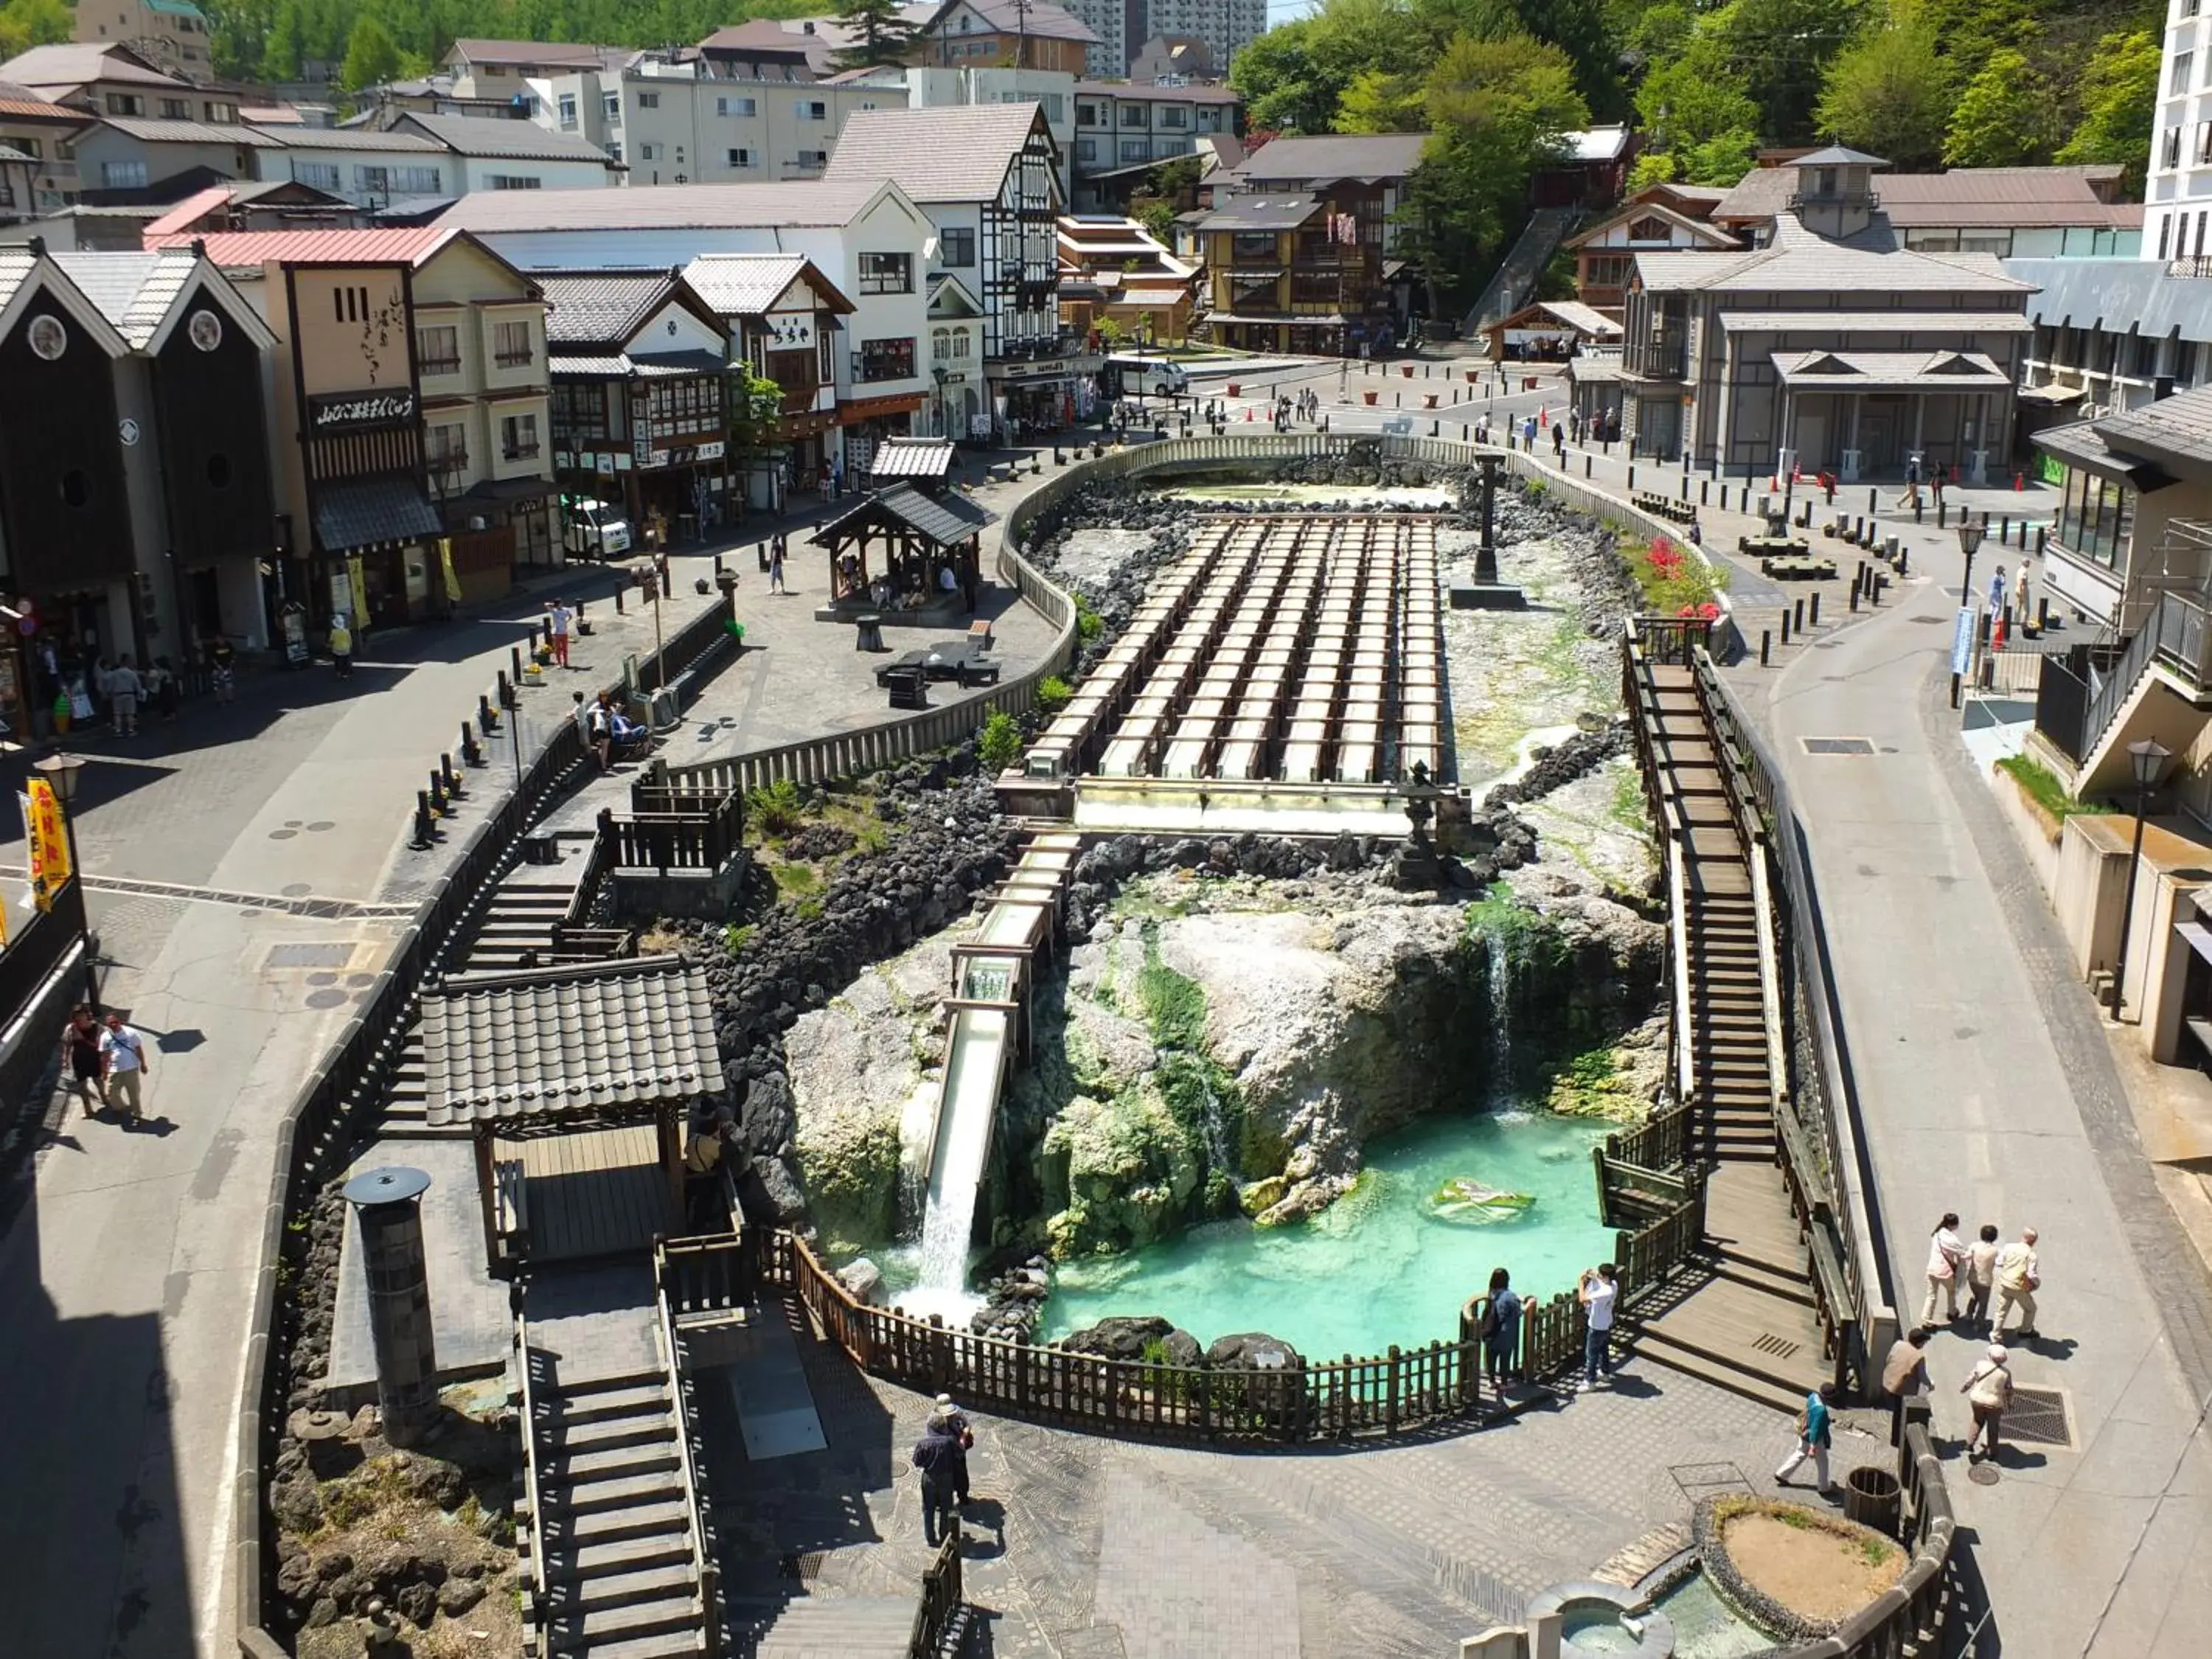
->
xmin=422 ymin=956 xmax=723 ymax=1126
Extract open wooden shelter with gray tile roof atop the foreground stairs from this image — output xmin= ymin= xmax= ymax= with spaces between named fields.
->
xmin=422 ymin=956 xmax=726 ymax=1272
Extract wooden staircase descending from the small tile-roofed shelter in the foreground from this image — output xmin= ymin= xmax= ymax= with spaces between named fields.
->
xmin=529 ymin=1371 xmax=710 ymax=1659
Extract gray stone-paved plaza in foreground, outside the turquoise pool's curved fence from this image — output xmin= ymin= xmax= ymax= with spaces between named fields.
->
xmin=706 ymin=1329 xmax=1889 ymax=1659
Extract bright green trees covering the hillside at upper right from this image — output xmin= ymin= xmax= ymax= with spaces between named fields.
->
xmin=1230 ymin=0 xmax=2166 ymax=307
